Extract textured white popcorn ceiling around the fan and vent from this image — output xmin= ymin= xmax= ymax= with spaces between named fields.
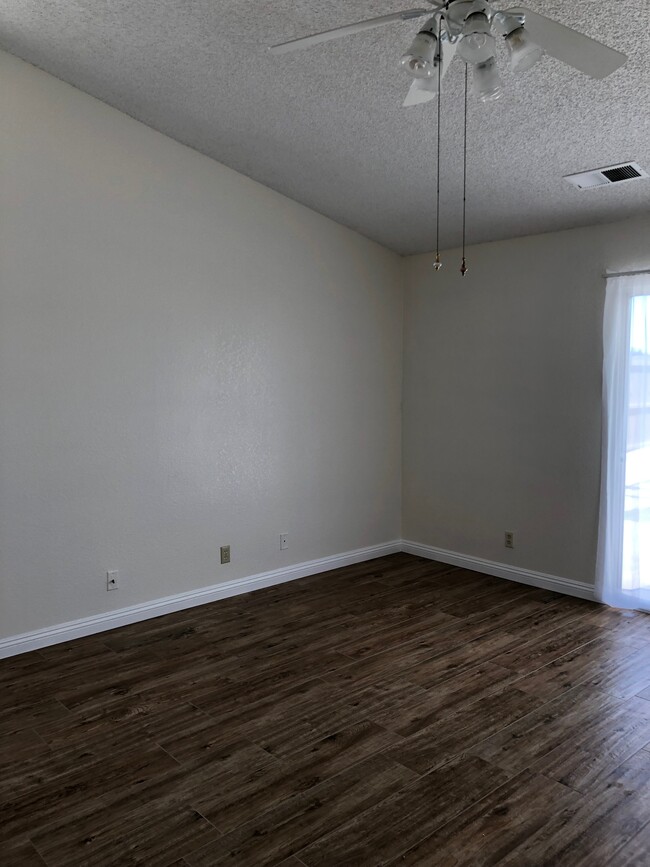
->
xmin=0 ymin=0 xmax=650 ymax=253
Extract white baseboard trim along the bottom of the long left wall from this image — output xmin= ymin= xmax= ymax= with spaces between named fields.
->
xmin=0 ymin=539 xmax=402 ymax=659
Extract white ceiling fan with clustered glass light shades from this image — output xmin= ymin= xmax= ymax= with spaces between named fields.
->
xmin=269 ymin=0 xmax=627 ymax=106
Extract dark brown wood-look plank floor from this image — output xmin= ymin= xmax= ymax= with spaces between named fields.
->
xmin=0 ymin=554 xmax=650 ymax=867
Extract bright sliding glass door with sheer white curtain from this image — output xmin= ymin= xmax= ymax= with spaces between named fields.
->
xmin=597 ymin=273 xmax=650 ymax=611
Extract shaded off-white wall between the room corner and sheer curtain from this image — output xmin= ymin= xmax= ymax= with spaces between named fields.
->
xmin=403 ymin=214 xmax=650 ymax=583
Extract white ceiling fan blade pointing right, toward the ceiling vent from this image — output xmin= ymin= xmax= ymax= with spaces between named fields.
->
xmin=505 ymin=6 xmax=627 ymax=78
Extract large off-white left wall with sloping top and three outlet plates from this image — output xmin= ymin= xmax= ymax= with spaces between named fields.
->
xmin=0 ymin=54 xmax=402 ymax=637
